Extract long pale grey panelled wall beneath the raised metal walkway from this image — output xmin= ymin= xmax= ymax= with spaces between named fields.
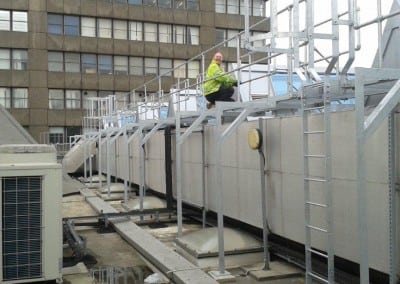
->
xmin=103 ymin=111 xmax=400 ymax=276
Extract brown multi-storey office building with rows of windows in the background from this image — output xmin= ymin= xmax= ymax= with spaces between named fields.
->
xmin=0 ymin=0 xmax=267 ymax=142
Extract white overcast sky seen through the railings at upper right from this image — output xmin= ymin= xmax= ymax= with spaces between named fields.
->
xmin=267 ymin=0 xmax=392 ymax=67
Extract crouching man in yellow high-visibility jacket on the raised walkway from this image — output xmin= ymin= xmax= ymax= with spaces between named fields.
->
xmin=203 ymin=52 xmax=237 ymax=108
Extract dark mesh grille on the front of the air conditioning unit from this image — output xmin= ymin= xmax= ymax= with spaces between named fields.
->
xmin=1 ymin=176 xmax=42 ymax=281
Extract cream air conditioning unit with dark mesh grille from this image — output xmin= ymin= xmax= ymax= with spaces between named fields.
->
xmin=0 ymin=144 xmax=63 ymax=283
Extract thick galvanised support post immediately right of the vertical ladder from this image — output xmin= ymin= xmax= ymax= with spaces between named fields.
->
xmin=355 ymin=68 xmax=369 ymax=283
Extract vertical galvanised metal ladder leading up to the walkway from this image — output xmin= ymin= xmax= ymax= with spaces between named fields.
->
xmin=301 ymin=81 xmax=335 ymax=283
